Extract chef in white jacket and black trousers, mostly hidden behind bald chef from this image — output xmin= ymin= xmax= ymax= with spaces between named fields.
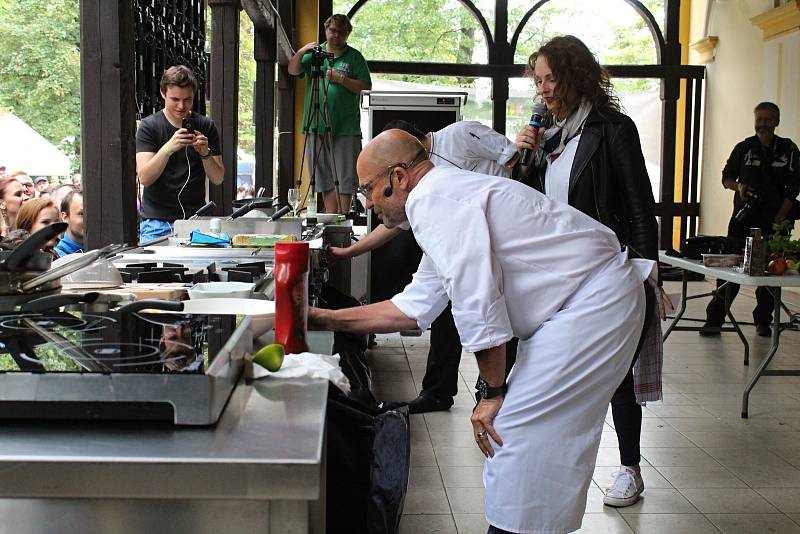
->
xmin=330 ymin=120 xmax=519 ymax=413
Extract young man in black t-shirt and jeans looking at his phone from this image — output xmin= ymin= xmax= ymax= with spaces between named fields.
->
xmin=136 ymin=65 xmax=225 ymax=242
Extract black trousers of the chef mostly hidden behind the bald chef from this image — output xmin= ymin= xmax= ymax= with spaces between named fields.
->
xmin=422 ymin=304 xmax=461 ymax=403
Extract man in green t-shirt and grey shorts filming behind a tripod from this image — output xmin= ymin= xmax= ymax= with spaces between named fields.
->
xmin=289 ymin=14 xmax=372 ymax=213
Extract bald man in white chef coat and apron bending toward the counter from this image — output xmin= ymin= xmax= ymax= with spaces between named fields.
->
xmin=309 ymin=130 xmax=654 ymax=534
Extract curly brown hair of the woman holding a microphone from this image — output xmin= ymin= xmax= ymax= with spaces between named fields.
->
xmin=525 ymin=35 xmax=619 ymax=120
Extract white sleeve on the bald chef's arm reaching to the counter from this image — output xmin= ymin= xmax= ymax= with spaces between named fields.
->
xmin=391 ymin=254 xmax=450 ymax=330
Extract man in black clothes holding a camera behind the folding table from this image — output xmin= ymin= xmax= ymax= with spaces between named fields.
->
xmin=700 ymin=102 xmax=800 ymax=337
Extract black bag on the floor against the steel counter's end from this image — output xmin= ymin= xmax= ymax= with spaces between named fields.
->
xmin=325 ymin=393 xmax=411 ymax=534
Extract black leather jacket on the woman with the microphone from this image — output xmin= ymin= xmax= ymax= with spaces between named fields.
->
xmin=521 ymin=110 xmax=658 ymax=261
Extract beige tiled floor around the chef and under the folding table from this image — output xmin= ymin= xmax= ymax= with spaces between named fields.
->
xmin=370 ymin=282 xmax=800 ymax=534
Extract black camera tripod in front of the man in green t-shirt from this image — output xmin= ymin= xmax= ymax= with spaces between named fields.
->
xmin=297 ymin=47 xmax=356 ymax=217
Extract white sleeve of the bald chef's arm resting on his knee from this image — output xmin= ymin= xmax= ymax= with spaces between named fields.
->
xmin=406 ymin=194 xmax=513 ymax=352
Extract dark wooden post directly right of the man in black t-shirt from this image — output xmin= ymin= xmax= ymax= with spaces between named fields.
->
xmin=208 ymin=0 xmax=241 ymax=215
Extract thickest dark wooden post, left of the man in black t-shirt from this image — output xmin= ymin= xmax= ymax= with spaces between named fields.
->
xmin=80 ymin=0 xmax=138 ymax=249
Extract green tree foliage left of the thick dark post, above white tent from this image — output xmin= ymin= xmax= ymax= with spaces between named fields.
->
xmin=0 ymin=0 xmax=81 ymax=168
